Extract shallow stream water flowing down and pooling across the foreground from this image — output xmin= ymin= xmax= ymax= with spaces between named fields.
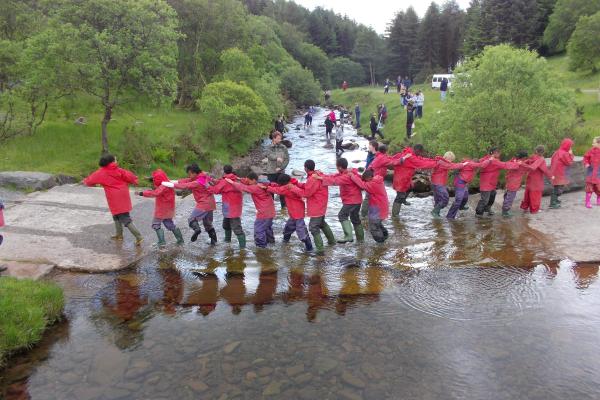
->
xmin=0 ymin=109 xmax=600 ymax=400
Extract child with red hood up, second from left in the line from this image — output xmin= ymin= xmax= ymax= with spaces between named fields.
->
xmin=137 ymin=168 xmax=184 ymax=247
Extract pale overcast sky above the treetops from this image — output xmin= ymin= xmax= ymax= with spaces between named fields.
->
xmin=294 ymin=0 xmax=469 ymax=33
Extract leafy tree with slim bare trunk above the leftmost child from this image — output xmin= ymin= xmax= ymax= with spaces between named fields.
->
xmin=44 ymin=0 xmax=179 ymax=152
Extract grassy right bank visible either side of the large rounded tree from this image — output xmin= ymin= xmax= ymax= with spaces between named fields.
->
xmin=332 ymin=56 xmax=600 ymax=154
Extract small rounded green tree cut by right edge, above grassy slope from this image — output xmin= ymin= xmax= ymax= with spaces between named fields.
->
xmin=567 ymin=12 xmax=600 ymax=72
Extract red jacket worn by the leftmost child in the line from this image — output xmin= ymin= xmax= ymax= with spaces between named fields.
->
xmin=83 ymin=162 xmax=137 ymax=215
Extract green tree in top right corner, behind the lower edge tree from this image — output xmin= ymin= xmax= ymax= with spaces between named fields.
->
xmin=544 ymin=0 xmax=600 ymax=53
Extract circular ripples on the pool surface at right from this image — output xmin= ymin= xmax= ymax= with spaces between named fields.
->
xmin=395 ymin=267 xmax=543 ymax=323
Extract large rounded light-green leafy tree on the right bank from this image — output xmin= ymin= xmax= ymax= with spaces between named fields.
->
xmin=432 ymin=45 xmax=576 ymax=157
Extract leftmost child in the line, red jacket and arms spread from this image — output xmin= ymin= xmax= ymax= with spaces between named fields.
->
xmin=83 ymin=154 xmax=144 ymax=246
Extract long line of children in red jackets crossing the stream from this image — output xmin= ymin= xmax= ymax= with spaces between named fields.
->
xmin=0 ymin=132 xmax=600 ymax=251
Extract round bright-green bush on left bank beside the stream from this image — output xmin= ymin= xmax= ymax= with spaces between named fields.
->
xmin=198 ymin=81 xmax=270 ymax=154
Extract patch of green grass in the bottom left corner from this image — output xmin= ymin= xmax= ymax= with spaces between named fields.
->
xmin=0 ymin=277 xmax=64 ymax=367
